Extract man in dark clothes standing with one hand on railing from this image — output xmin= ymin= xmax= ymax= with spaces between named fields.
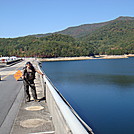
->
xmin=22 ymin=62 xmax=43 ymax=102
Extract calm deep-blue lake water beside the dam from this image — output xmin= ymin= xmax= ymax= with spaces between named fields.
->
xmin=42 ymin=58 xmax=134 ymax=134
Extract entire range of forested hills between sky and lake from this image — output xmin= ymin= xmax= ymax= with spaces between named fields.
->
xmin=0 ymin=17 xmax=134 ymax=57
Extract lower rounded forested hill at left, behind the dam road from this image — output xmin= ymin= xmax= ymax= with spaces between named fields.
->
xmin=0 ymin=34 xmax=86 ymax=57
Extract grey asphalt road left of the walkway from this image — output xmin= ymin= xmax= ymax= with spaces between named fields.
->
xmin=0 ymin=61 xmax=25 ymax=134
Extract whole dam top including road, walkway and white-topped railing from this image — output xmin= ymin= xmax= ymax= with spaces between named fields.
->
xmin=0 ymin=58 xmax=94 ymax=134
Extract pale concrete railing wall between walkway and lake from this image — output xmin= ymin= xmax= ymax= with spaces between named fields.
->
xmin=36 ymin=61 xmax=94 ymax=134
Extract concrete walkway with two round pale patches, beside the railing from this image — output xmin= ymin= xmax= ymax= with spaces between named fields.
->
xmin=10 ymin=61 xmax=55 ymax=134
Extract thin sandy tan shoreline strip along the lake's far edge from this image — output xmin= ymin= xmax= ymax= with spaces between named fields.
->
xmin=38 ymin=54 xmax=134 ymax=61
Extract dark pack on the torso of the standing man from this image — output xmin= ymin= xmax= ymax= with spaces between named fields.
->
xmin=24 ymin=66 xmax=36 ymax=80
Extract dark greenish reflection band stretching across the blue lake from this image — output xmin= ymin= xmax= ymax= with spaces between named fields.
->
xmin=52 ymin=73 xmax=134 ymax=88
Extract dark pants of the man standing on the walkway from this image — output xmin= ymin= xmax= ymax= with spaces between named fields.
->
xmin=23 ymin=80 xmax=37 ymax=100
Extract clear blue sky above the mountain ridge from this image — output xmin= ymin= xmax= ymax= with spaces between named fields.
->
xmin=0 ymin=0 xmax=134 ymax=38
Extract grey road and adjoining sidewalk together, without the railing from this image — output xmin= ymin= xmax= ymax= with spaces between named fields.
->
xmin=0 ymin=60 xmax=54 ymax=134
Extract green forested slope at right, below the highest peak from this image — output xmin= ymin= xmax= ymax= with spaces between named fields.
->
xmin=80 ymin=18 xmax=134 ymax=54
